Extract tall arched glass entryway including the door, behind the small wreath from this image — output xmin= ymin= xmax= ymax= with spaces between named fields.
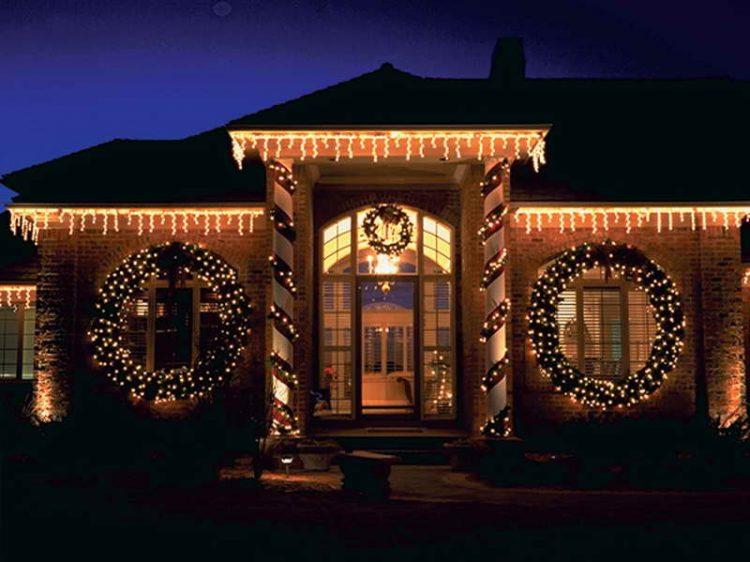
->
xmin=315 ymin=208 xmax=455 ymax=419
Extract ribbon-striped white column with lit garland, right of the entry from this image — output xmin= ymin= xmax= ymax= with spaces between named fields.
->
xmin=479 ymin=162 xmax=510 ymax=437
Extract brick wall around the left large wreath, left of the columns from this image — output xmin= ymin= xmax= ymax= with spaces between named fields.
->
xmin=35 ymin=221 xmax=271 ymax=419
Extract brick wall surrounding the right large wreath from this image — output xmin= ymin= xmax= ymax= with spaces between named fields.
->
xmin=509 ymin=222 xmax=745 ymax=433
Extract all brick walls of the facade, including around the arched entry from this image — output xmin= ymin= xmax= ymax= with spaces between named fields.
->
xmin=17 ymin=168 xmax=750 ymax=435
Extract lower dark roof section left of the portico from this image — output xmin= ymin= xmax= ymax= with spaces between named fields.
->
xmin=2 ymin=128 xmax=266 ymax=204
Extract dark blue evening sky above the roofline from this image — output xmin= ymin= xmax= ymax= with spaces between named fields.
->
xmin=0 ymin=0 xmax=750 ymax=204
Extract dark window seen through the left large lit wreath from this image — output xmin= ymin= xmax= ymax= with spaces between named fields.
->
xmin=127 ymin=279 xmax=219 ymax=371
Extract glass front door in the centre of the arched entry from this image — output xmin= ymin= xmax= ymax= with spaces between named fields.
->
xmin=359 ymin=279 xmax=419 ymax=416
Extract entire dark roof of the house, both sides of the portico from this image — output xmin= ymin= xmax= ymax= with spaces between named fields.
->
xmin=2 ymin=63 xmax=750 ymax=203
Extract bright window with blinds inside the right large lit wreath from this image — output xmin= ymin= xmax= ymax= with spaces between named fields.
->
xmin=557 ymin=268 xmax=656 ymax=379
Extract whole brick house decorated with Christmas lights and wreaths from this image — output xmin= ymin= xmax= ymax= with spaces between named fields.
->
xmin=0 ymin=39 xmax=750 ymax=437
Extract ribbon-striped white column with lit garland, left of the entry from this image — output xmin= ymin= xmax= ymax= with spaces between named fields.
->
xmin=267 ymin=161 xmax=298 ymax=435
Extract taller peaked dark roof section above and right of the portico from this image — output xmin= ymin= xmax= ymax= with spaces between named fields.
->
xmin=227 ymin=64 xmax=750 ymax=202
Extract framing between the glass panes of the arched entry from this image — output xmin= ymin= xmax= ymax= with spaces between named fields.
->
xmin=313 ymin=205 xmax=460 ymax=422
